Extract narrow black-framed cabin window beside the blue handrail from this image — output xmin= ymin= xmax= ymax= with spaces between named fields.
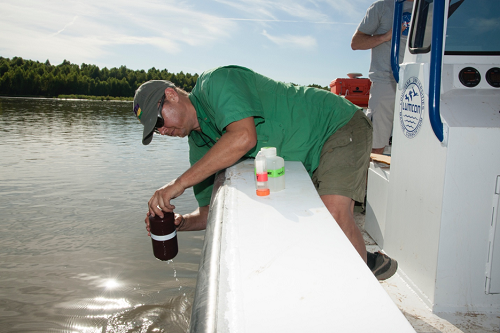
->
xmin=409 ymin=0 xmax=434 ymax=53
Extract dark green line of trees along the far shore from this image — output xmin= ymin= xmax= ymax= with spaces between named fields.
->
xmin=0 ymin=57 xmax=198 ymax=99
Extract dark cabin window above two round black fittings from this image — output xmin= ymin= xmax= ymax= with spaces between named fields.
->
xmin=444 ymin=0 xmax=500 ymax=55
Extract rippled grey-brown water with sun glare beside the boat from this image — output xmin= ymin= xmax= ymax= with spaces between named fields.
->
xmin=0 ymin=98 xmax=204 ymax=332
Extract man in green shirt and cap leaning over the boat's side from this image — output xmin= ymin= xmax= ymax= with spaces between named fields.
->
xmin=133 ymin=66 xmax=394 ymax=278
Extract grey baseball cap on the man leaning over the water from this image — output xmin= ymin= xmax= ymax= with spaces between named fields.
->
xmin=133 ymin=80 xmax=175 ymax=145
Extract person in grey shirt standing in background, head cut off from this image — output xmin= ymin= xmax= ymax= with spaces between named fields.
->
xmin=351 ymin=0 xmax=413 ymax=154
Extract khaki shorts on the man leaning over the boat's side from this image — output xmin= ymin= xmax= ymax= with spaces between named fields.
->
xmin=312 ymin=110 xmax=373 ymax=202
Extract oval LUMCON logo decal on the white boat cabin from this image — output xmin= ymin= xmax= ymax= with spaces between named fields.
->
xmin=399 ymin=76 xmax=424 ymax=139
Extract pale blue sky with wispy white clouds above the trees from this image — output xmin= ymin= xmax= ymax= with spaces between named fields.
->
xmin=0 ymin=0 xmax=374 ymax=86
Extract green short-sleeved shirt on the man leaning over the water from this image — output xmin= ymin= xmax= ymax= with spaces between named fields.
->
xmin=188 ymin=66 xmax=359 ymax=207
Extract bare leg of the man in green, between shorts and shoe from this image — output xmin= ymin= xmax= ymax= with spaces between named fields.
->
xmin=321 ymin=194 xmax=366 ymax=262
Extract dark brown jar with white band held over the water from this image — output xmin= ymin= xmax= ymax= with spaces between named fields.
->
xmin=149 ymin=212 xmax=179 ymax=260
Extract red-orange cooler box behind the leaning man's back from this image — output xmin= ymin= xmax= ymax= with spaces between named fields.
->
xmin=330 ymin=78 xmax=372 ymax=108
